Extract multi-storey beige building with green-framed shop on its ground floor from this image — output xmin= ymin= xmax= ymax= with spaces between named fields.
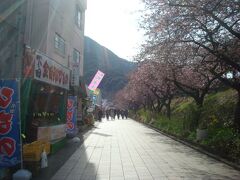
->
xmin=22 ymin=0 xmax=86 ymax=142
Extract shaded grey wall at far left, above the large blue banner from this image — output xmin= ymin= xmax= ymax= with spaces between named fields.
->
xmin=0 ymin=0 xmax=26 ymax=79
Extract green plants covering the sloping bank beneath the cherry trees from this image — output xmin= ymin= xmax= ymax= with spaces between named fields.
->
xmin=138 ymin=90 xmax=240 ymax=163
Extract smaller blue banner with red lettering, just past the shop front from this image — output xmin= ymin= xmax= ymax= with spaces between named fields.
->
xmin=66 ymin=96 xmax=77 ymax=134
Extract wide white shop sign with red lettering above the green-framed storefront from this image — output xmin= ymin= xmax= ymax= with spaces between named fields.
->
xmin=34 ymin=53 xmax=70 ymax=89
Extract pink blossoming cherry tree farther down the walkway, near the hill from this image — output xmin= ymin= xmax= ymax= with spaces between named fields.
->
xmin=115 ymin=62 xmax=176 ymax=118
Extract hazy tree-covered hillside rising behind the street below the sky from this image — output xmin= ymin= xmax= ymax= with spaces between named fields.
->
xmin=84 ymin=37 xmax=135 ymax=99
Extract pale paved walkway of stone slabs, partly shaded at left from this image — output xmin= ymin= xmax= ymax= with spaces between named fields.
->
xmin=52 ymin=119 xmax=240 ymax=180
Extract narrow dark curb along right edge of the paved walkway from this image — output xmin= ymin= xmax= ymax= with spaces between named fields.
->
xmin=135 ymin=120 xmax=240 ymax=171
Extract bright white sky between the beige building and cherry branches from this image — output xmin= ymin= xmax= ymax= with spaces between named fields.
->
xmin=85 ymin=0 xmax=143 ymax=61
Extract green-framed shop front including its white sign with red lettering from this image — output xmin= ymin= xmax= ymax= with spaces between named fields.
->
xmin=21 ymin=50 xmax=70 ymax=143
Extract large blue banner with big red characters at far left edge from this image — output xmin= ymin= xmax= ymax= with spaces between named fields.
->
xmin=0 ymin=80 xmax=21 ymax=167
